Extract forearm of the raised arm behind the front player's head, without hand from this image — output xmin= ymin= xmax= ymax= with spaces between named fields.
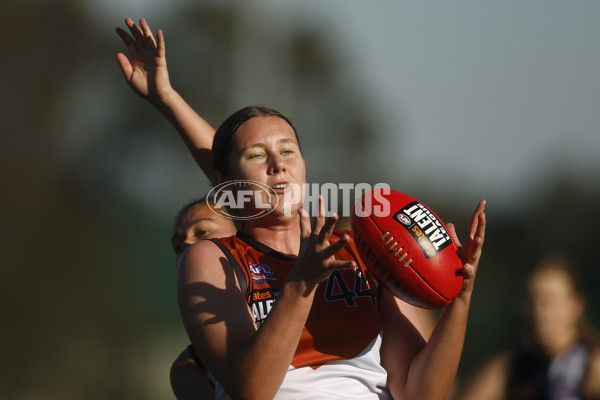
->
xmin=151 ymin=90 xmax=215 ymax=178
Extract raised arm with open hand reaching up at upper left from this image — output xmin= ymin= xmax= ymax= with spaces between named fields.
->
xmin=117 ymin=18 xmax=215 ymax=177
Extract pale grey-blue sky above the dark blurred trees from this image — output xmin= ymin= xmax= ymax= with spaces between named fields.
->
xmin=88 ymin=0 xmax=600 ymax=214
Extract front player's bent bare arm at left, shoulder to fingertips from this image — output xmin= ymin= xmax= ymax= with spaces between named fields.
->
xmin=178 ymin=205 xmax=355 ymax=400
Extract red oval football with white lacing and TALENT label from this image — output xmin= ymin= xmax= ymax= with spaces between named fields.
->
xmin=352 ymin=189 xmax=463 ymax=308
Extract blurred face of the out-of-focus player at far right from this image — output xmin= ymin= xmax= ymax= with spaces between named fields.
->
xmin=529 ymin=269 xmax=584 ymax=339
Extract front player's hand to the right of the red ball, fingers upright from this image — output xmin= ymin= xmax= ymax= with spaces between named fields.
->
xmin=448 ymin=200 xmax=486 ymax=296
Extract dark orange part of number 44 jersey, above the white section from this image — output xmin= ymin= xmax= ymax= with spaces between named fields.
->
xmin=218 ymin=231 xmax=381 ymax=368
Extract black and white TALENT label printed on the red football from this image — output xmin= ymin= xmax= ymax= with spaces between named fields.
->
xmin=394 ymin=201 xmax=452 ymax=258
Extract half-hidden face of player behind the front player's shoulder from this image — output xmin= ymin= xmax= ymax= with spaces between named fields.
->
xmin=171 ymin=203 xmax=236 ymax=255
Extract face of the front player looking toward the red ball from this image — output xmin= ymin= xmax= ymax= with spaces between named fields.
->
xmin=229 ymin=116 xmax=306 ymax=219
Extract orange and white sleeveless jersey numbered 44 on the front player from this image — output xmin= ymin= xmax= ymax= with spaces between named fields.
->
xmin=211 ymin=231 xmax=389 ymax=399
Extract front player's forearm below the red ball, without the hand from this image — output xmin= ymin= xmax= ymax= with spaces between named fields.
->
xmin=405 ymin=297 xmax=470 ymax=400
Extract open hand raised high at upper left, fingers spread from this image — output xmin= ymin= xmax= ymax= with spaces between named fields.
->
xmin=116 ymin=18 xmax=174 ymax=105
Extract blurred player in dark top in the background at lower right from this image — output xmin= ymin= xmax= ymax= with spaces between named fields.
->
xmin=461 ymin=255 xmax=600 ymax=400
